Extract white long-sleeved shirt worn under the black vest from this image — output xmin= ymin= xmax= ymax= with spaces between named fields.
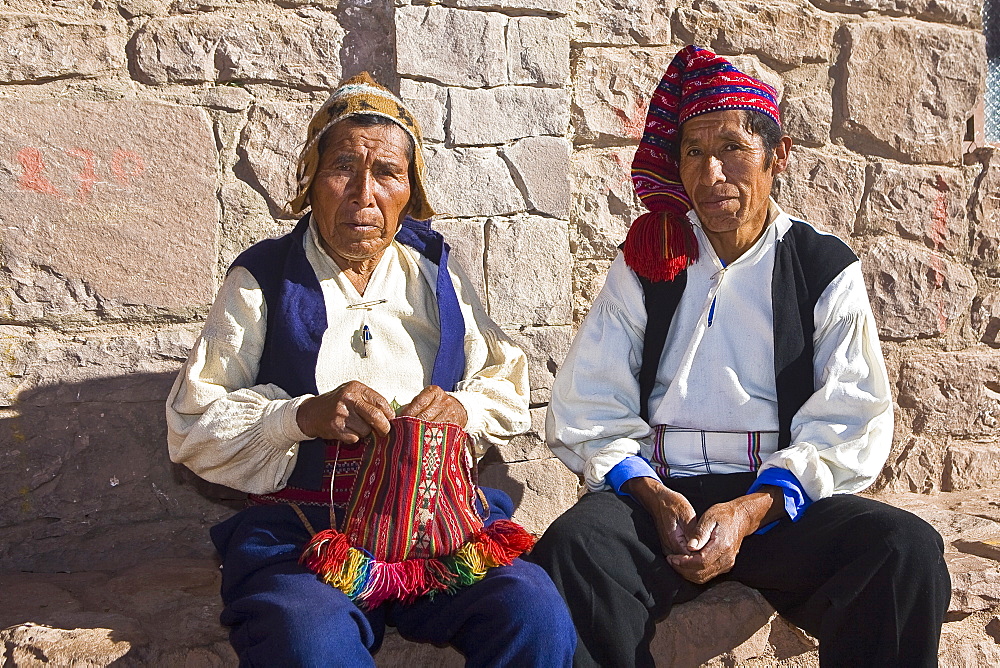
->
xmin=546 ymin=206 xmax=893 ymax=500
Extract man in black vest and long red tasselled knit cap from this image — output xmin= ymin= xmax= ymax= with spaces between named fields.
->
xmin=531 ymin=46 xmax=950 ymax=666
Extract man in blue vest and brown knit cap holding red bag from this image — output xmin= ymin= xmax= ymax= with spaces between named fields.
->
xmin=167 ymin=74 xmax=576 ymax=666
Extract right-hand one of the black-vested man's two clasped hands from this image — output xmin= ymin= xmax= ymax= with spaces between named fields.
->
xmin=667 ymin=485 xmax=784 ymax=584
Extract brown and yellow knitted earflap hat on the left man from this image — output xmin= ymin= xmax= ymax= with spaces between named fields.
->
xmin=288 ymin=72 xmax=434 ymax=220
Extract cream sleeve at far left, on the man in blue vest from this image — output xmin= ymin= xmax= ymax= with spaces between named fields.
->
xmin=167 ymin=267 xmax=312 ymax=494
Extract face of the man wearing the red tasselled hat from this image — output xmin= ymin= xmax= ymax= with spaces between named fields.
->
xmin=680 ymin=110 xmax=791 ymax=239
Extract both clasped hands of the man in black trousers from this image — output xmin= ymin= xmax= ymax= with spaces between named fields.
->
xmin=622 ymin=478 xmax=784 ymax=584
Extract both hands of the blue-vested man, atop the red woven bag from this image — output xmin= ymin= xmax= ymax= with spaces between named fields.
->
xmin=295 ymin=380 xmax=468 ymax=444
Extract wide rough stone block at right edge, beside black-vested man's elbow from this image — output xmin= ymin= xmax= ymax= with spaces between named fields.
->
xmin=898 ymin=349 xmax=1000 ymax=440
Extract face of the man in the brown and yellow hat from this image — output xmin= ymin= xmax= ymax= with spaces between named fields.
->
xmin=309 ymin=120 xmax=410 ymax=262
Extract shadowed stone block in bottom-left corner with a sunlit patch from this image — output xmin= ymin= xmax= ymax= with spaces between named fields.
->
xmin=0 ymin=559 xmax=236 ymax=668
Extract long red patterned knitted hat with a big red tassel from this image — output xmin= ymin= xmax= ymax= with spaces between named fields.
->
xmin=622 ymin=45 xmax=781 ymax=281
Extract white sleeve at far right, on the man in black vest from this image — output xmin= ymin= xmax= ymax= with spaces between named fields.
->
xmin=761 ymin=262 xmax=893 ymax=500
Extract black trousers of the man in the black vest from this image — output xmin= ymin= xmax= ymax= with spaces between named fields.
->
xmin=528 ymin=474 xmax=951 ymax=668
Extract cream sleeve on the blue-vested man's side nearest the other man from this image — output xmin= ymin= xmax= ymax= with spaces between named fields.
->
xmin=449 ymin=263 xmax=531 ymax=456
